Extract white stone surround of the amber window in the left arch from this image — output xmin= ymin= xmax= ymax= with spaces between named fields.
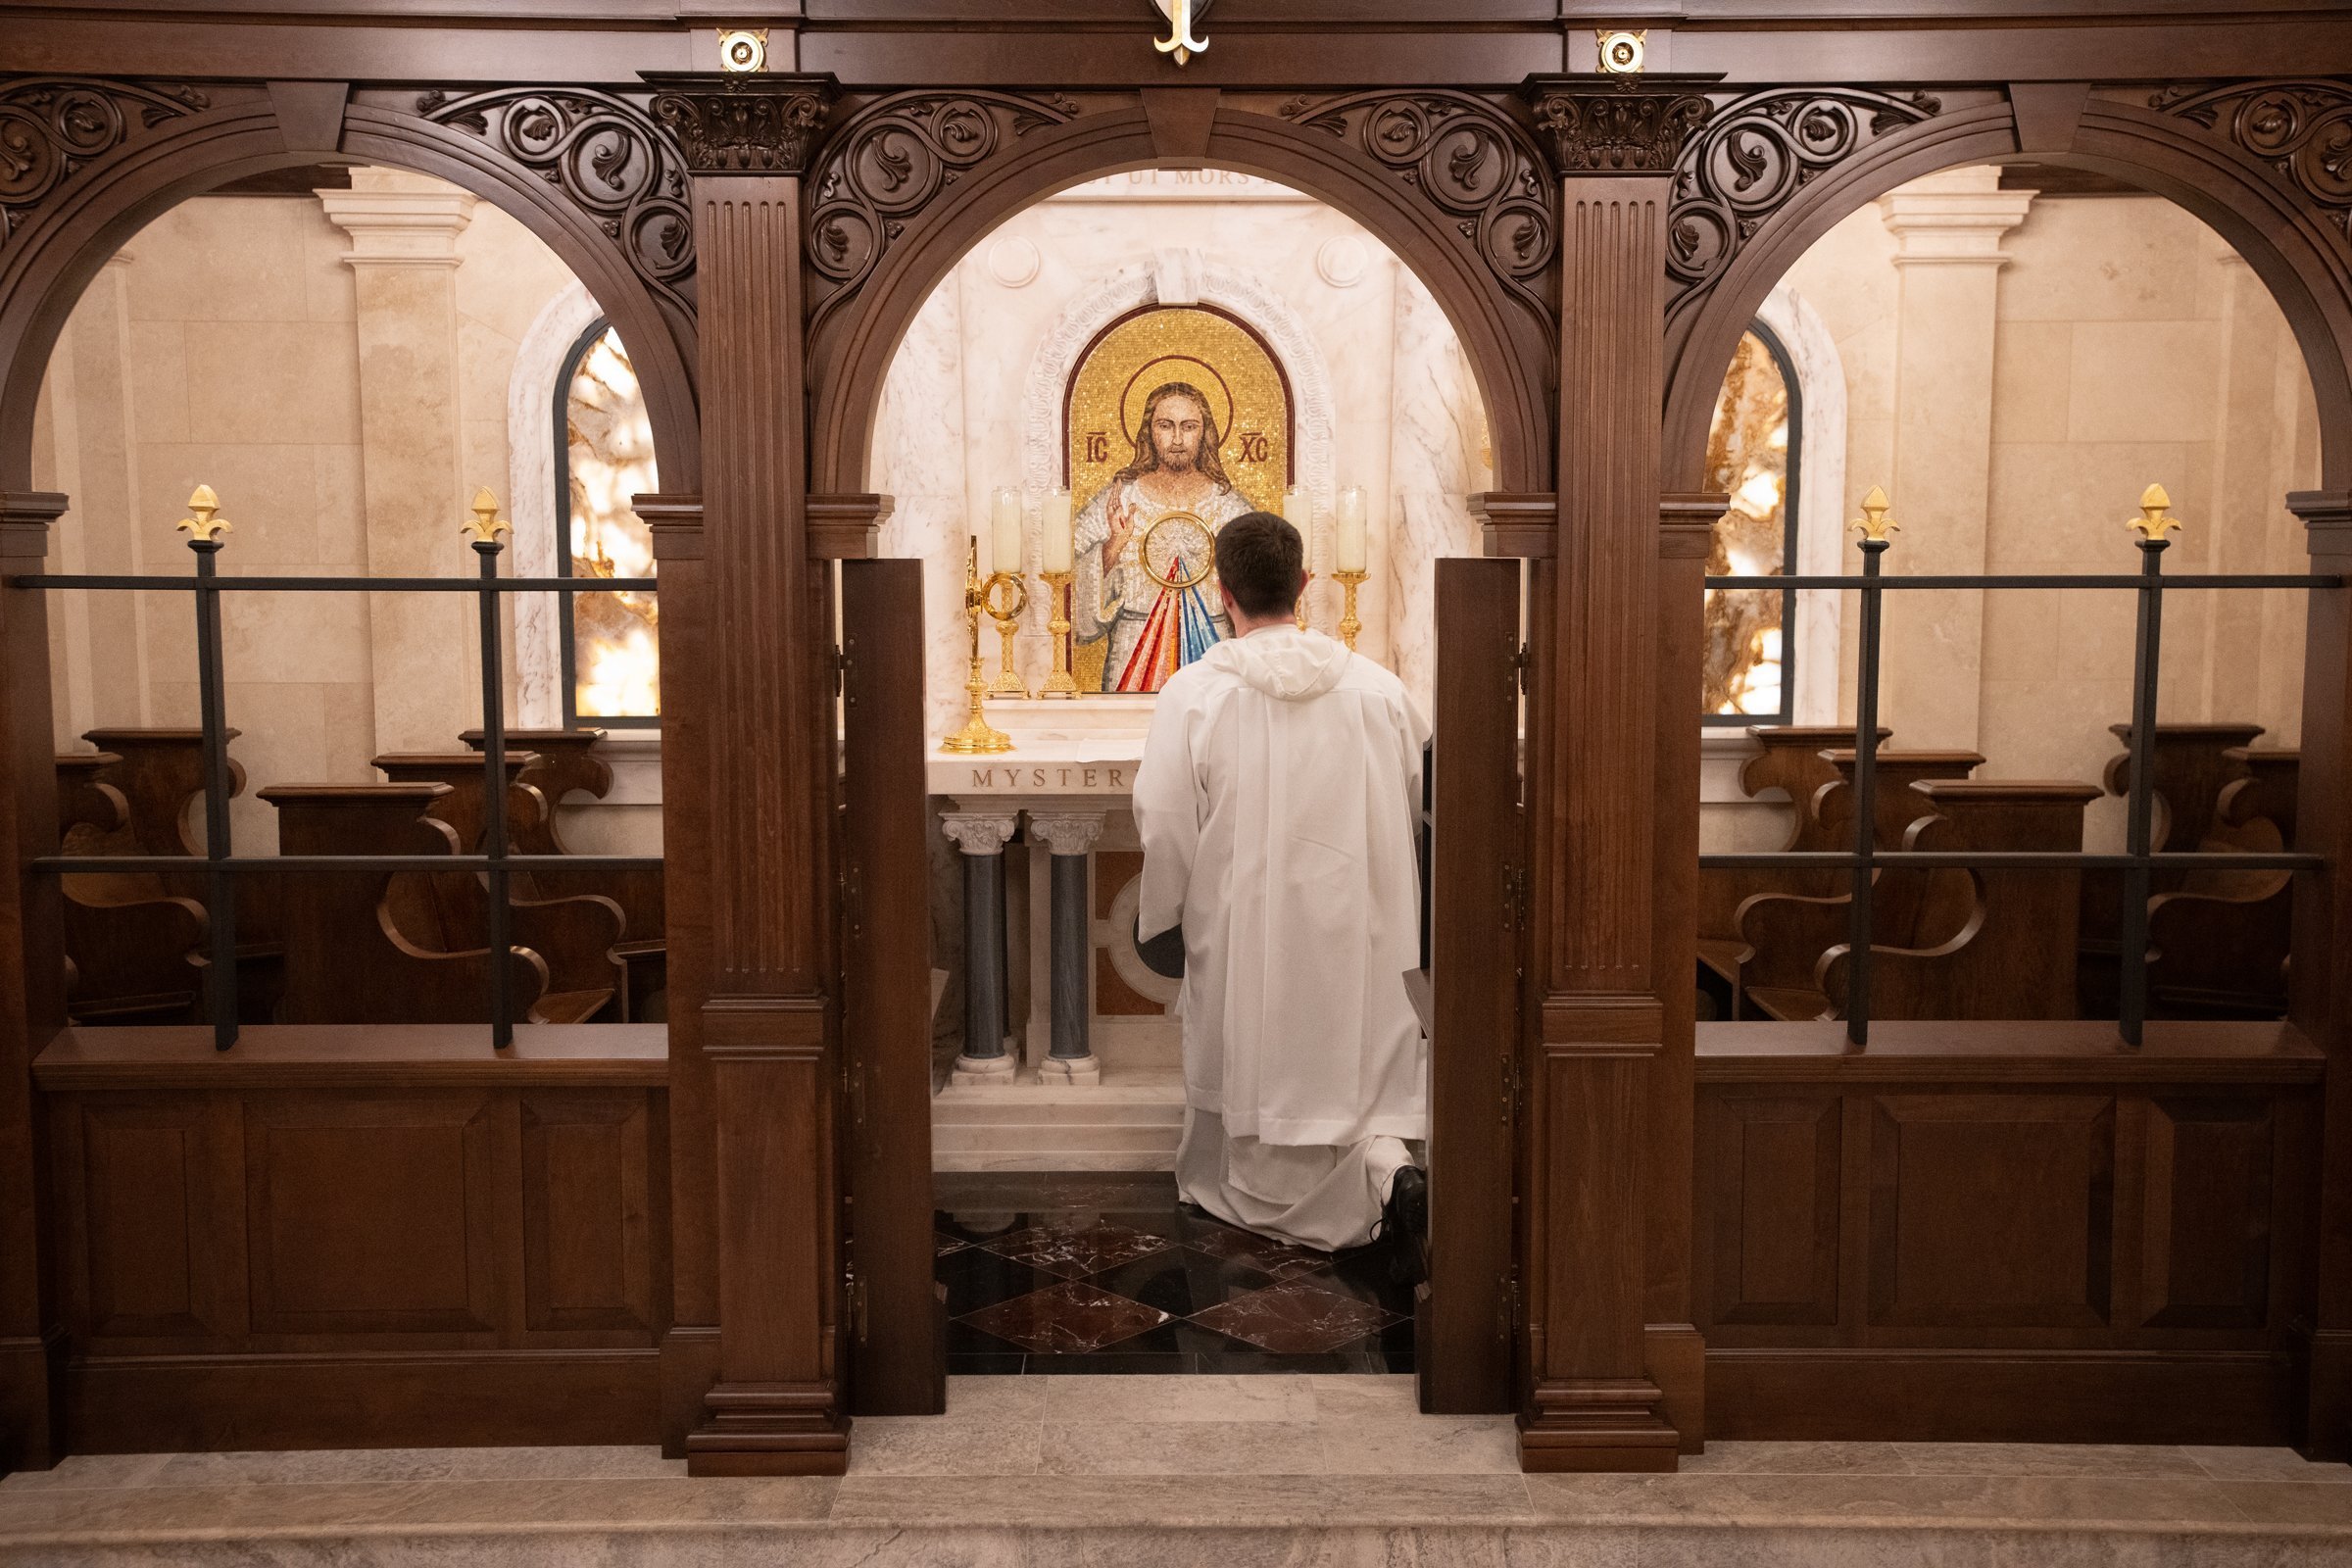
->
xmin=506 ymin=279 xmax=605 ymax=729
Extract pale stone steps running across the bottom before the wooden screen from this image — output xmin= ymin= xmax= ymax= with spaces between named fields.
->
xmin=0 ymin=1375 xmax=2352 ymax=1568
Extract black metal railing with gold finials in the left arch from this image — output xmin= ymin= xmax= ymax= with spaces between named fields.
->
xmin=7 ymin=487 xmax=661 ymax=1051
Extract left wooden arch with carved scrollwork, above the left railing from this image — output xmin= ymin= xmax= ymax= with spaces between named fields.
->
xmin=0 ymin=77 xmax=701 ymax=489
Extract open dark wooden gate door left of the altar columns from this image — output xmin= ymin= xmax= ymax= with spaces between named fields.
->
xmin=842 ymin=560 xmax=948 ymax=1415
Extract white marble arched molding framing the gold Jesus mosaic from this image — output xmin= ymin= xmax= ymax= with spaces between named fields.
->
xmin=1021 ymin=247 xmax=1334 ymax=627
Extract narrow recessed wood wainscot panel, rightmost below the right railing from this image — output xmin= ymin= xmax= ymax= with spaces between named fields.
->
xmin=2140 ymin=1096 xmax=2277 ymax=1328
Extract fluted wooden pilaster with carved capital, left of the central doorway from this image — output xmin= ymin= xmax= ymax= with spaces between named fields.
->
xmin=654 ymin=75 xmax=849 ymax=1474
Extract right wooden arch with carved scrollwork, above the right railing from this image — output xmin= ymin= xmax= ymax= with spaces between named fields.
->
xmin=1663 ymin=80 xmax=2352 ymax=491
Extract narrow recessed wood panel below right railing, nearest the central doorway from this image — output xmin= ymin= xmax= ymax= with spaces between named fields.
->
xmin=1700 ymin=1093 xmax=1844 ymax=1343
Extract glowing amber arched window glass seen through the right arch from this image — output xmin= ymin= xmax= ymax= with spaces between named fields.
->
xmin=1700 ymin=331 xmax=1794 ymax=714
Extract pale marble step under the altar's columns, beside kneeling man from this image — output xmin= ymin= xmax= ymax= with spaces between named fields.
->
xmin=931 ymin=1065 xmax=1183 ymax=1171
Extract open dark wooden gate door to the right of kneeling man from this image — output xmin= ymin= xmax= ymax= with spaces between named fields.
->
xmin=1413 ymin=560 xmax=1527 ymax=1415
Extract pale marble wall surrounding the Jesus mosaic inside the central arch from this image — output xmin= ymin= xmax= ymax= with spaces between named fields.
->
xmin=868 ymin=170 xmax=1492 ymax=733
